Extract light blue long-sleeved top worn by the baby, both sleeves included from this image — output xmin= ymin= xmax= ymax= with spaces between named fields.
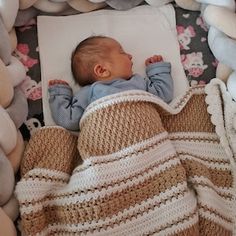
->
xmin=48 ymin=62 xmax=173 ymax=130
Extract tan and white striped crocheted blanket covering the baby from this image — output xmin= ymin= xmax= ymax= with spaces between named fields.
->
xmin=16 ymin=80 xmax=236 ymax=236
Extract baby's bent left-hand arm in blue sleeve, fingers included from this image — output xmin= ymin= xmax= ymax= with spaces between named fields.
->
xmin=48 ymin=80 xmax=84 ymax=130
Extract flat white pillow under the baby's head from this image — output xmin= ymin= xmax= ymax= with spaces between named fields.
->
xmin=37 ymin=4 xmax=188 ymax=125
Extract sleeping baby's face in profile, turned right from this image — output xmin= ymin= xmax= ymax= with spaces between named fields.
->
xmin=105 ymin=39 xmax=133 ymax=79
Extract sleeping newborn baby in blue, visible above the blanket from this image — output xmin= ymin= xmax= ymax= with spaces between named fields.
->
xmin=48 ymin=36 xmax=173 ymax=130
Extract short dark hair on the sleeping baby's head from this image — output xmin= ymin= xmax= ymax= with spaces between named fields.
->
xmin=71 ymin=36 xmax=109 ymax=86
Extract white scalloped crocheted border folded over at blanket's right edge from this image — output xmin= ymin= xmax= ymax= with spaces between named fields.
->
xmin=205 ymin=79 xmax=236 ymax=235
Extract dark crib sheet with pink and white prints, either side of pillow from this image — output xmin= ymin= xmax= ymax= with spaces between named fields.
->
xmin=14 ymin=4 xmax=217 ymax=140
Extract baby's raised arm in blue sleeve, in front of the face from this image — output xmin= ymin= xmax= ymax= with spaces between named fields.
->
xmin=145 ymin=55 xmax=173 ymax=103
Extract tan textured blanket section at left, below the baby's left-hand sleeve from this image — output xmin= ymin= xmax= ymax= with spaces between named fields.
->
xmin=21 ymin=128 xmax=78 ymax=176
